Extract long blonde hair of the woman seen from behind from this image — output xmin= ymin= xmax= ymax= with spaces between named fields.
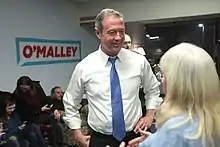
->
xmin=156 ymin=43 xmax=220 ymax=146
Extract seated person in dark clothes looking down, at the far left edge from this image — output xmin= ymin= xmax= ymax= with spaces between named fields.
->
xmin=0 ymin=92 xmax=39 ymax=147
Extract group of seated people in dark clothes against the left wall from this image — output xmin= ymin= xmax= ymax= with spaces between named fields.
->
xmin=0 ymin=76 xmax=67 ymax=147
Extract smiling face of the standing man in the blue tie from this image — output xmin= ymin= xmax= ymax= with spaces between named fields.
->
xmin=96 ymin=16 xmax=125 ymax=56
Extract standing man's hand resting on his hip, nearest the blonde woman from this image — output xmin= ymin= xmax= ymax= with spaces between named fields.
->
xmin=134 ymin=110 xmax=154 ymax=133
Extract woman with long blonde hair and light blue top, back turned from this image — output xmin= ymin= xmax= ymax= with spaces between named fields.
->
xmin=120 ymin=43 xmax=220 ymax=147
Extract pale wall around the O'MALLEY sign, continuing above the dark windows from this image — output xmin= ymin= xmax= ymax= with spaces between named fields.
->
xmin=0 ymin=0 xmax=220 ymax=94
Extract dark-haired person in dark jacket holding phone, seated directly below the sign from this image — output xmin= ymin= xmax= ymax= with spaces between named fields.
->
xmin=12 ymin=76 xmax=50 ymax=147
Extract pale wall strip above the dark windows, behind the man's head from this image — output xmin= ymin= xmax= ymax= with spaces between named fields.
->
xmin=77 ymin=0 xmax=220 ymax=22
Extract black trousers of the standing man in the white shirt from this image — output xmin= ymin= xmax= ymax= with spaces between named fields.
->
xmin=89 ymin=130 xmax=140 ymax=147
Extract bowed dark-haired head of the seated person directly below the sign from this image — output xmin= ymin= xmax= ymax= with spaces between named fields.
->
xmin=17 ymin=76 xmax=33 ymax=93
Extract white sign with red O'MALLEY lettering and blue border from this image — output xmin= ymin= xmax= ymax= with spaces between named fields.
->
xmin=15 ymin=37 xmax=81 ymax=66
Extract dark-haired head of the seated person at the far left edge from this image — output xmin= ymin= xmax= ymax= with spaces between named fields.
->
xmin=0 ymin=92 xmax=15 ymax=117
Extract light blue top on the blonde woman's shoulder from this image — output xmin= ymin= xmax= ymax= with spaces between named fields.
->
xmin=140 ymin=115 xmax=201 ymax=147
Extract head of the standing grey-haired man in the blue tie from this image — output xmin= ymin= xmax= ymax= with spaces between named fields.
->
xmin=95 ymin=9 xmax=125 ymax=56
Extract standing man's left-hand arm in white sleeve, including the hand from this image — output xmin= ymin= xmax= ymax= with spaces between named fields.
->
xmin=63 ymin=63 xmax=90 ymax=147
